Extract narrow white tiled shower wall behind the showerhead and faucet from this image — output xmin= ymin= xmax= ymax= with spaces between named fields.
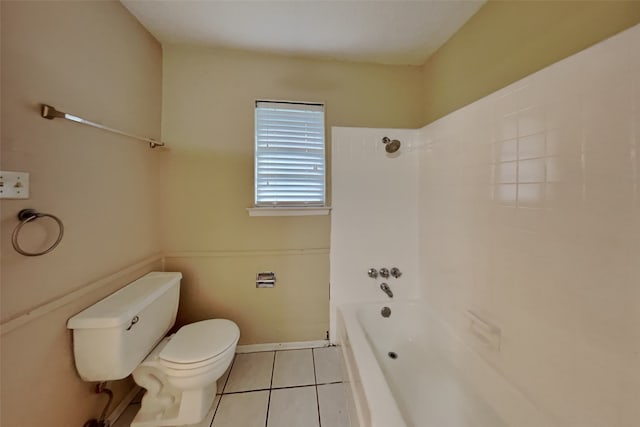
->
xmin=330 ymin=127 xmax=418 ymax=341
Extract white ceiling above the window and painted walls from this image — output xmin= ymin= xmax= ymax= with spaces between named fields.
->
xmin=121 ymin=0 xmax=486 ymax=65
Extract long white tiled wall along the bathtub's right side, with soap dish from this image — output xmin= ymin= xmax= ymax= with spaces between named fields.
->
xmin=418 ymin=26 xmax=640 ymax=427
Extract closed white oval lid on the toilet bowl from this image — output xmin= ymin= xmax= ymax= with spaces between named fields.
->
xmin=158 ymin=319 xmax=240 ymax=363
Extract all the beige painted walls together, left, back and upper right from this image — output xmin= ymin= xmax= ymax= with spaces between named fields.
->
xmin=0 ymin=1 xmax=638 ymax=427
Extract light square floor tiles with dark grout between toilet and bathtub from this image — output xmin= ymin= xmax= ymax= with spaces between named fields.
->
xmin=113 ymin=347 xmax=350 ymax=427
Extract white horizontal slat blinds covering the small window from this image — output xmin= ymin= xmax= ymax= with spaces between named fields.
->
xmin=255 ymin=101 xmax=325 ymax=206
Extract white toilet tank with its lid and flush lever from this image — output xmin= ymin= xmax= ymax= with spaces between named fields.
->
xmin=67 ymin=272 xmax=182 ymax=381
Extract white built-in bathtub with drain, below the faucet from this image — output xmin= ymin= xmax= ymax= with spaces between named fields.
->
xmin=337 ymin=302 xmax=552 ymax=427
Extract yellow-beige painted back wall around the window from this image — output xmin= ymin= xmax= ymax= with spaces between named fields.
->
xmin=162 ymin=46 xmax=421 ymax=343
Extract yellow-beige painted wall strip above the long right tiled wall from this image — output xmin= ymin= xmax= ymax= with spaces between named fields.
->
xmin=423 ymin=0 xmax=640 ymax=124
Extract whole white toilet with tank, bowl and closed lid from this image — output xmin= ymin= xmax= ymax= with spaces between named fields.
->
xmin=67 ymin=272 xmax=240 ymax=427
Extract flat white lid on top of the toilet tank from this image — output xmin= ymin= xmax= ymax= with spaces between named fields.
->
xmin=67 ymin=271 xmax=182 ymax=329
